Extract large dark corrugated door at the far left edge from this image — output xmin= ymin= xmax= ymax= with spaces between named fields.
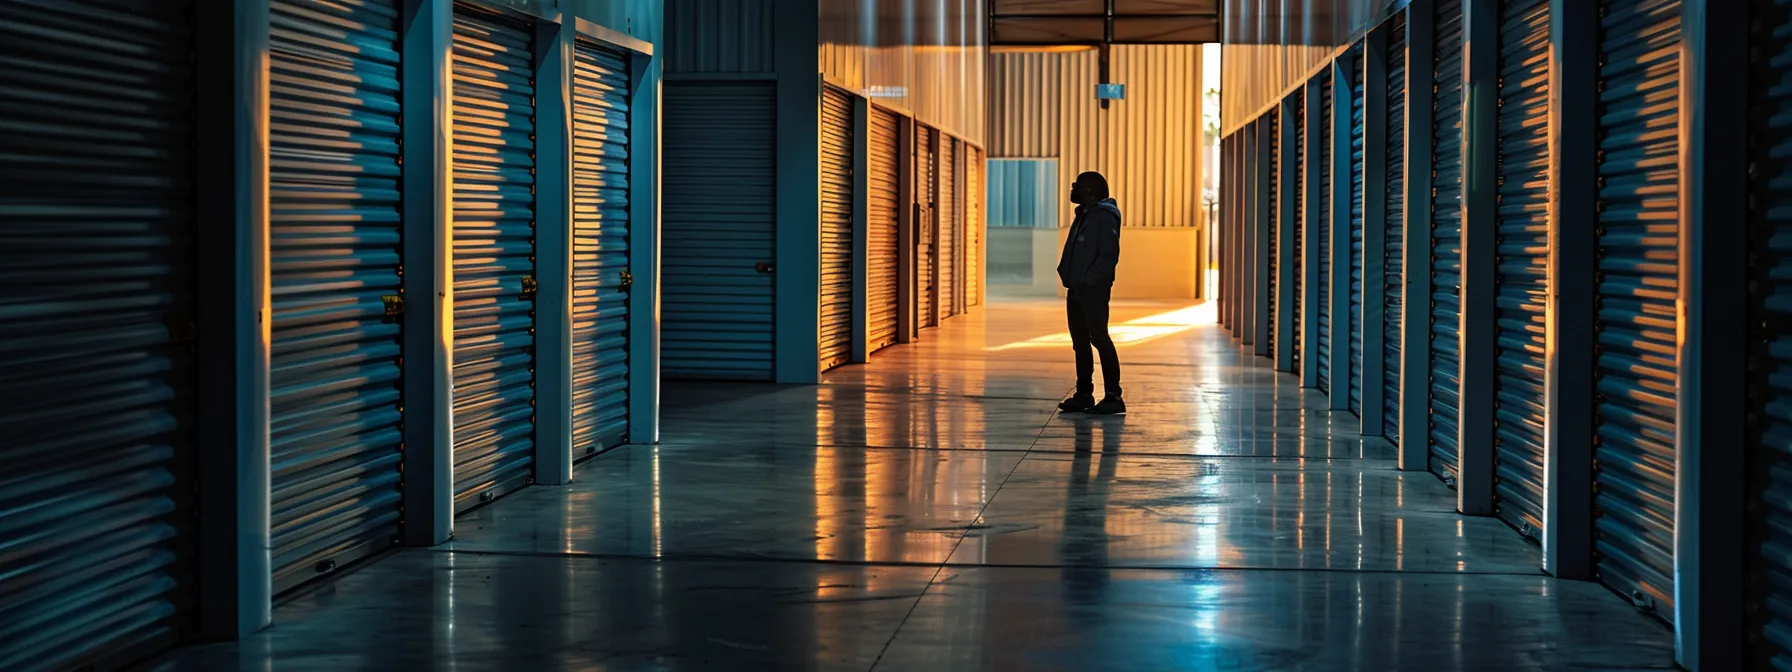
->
xmin=0 ymin=0 xmax=197 ymax=670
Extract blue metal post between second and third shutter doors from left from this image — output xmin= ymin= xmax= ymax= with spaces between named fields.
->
xmin=400 ymin=0 xmax=453 ymax=547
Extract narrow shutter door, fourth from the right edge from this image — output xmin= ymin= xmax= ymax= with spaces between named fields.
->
xmin=1430 ymin=0 xmax=1462 ymax=480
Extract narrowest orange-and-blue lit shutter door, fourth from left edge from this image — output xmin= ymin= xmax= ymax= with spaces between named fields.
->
xmin=572 ymin=41 xmax=634 ymax=455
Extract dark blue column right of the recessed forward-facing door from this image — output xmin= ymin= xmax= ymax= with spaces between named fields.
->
xmin=772 ymin=0 xmax=821 ymax=383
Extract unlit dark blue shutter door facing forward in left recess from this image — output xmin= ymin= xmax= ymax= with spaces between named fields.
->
xmin=659 ymin=82 xmax=778 ymax=380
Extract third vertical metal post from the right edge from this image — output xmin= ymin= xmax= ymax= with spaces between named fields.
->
xmin=1457 ymin=0 xmax=1500 ymax=516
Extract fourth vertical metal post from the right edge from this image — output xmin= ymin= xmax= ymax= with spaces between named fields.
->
xmin=1400 ymin=0 xmax=1440 ymax=471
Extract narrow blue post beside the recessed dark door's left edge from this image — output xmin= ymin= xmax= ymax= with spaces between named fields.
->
xmin=629 ymin=30 xmax=663 ymax=444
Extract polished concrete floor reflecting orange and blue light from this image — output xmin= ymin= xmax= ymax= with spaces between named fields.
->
xmin=156 ymin=301 xmax=1672 ymax=672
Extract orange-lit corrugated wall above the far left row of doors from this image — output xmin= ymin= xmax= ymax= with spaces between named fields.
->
xmin=820 ymin=0 xmax=989 ymax=145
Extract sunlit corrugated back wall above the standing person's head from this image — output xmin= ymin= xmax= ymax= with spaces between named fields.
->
xmin=989 ymin=45 xmax=1202 ymax=226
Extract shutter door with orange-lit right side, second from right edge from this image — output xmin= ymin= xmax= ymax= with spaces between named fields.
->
xmin=1593 ymin=0 xmax=1681 ymax=616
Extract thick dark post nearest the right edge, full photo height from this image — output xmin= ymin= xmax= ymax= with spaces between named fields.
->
xmin=1674 ymin=0 xmax=1749 ymax=672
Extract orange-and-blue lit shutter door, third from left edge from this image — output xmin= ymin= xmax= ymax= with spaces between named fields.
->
xmin=453 ymin=7 xmax=536 ymax=511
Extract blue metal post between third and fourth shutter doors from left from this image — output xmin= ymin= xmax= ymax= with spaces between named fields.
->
xmin=534 ymin=20 xmax=573 ymax=486
